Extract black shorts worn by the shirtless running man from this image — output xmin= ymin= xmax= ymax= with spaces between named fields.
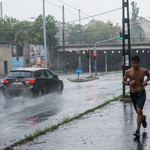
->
xmin=130 ymin=90 xmax=146 ymax=110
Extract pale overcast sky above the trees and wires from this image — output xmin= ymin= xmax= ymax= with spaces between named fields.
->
xmin=0 ymin=0 xmax=150 ymax=26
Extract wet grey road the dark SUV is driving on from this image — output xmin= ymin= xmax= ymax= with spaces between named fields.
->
xmin=0 ymin=73 xmax=127 ymax=148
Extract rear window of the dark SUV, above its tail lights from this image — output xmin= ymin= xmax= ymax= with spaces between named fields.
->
xmin=7 ymin=71 xmax=32 ymax=78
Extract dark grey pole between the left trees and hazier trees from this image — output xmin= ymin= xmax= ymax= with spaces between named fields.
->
xmin=62 ymin=5 xmax=66 ymax=71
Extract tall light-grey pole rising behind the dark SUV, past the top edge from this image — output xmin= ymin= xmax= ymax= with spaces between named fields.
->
xmin=43 ymin=0 xmax=47 ymax=68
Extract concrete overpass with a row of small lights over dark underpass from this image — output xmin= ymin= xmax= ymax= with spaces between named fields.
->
xmin=56 ymin=43 xmax=150 ymax=71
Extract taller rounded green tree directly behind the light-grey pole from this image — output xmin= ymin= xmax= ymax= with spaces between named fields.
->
xmin=28 ymin=15 xmax=59 ymax=47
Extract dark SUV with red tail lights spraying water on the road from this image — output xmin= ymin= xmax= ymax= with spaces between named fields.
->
xmin=3 ymin=68 xmax=63 ymax=100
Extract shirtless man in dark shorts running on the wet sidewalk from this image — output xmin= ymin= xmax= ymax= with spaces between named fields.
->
xmin=123 ymin=55 xmax=150 ymax=136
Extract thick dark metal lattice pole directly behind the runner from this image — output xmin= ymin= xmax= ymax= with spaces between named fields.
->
xmin=122 ymin=0 xmax=131 ymax=98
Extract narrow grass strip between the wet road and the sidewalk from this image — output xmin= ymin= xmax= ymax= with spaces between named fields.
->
xmin=4 ymin=95 xmax=122 ymax=150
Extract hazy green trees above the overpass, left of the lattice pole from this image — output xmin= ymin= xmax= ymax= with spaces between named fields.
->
xmin=66 ymin=21 xmax=121 ymax=44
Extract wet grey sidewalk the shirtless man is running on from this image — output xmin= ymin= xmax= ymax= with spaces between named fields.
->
xmin=14 ymin=96 xmax=150 ymax=150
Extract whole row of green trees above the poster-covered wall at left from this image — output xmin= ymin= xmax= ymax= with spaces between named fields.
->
xmin=0 ymin=15 xmax=59 ymax=46
